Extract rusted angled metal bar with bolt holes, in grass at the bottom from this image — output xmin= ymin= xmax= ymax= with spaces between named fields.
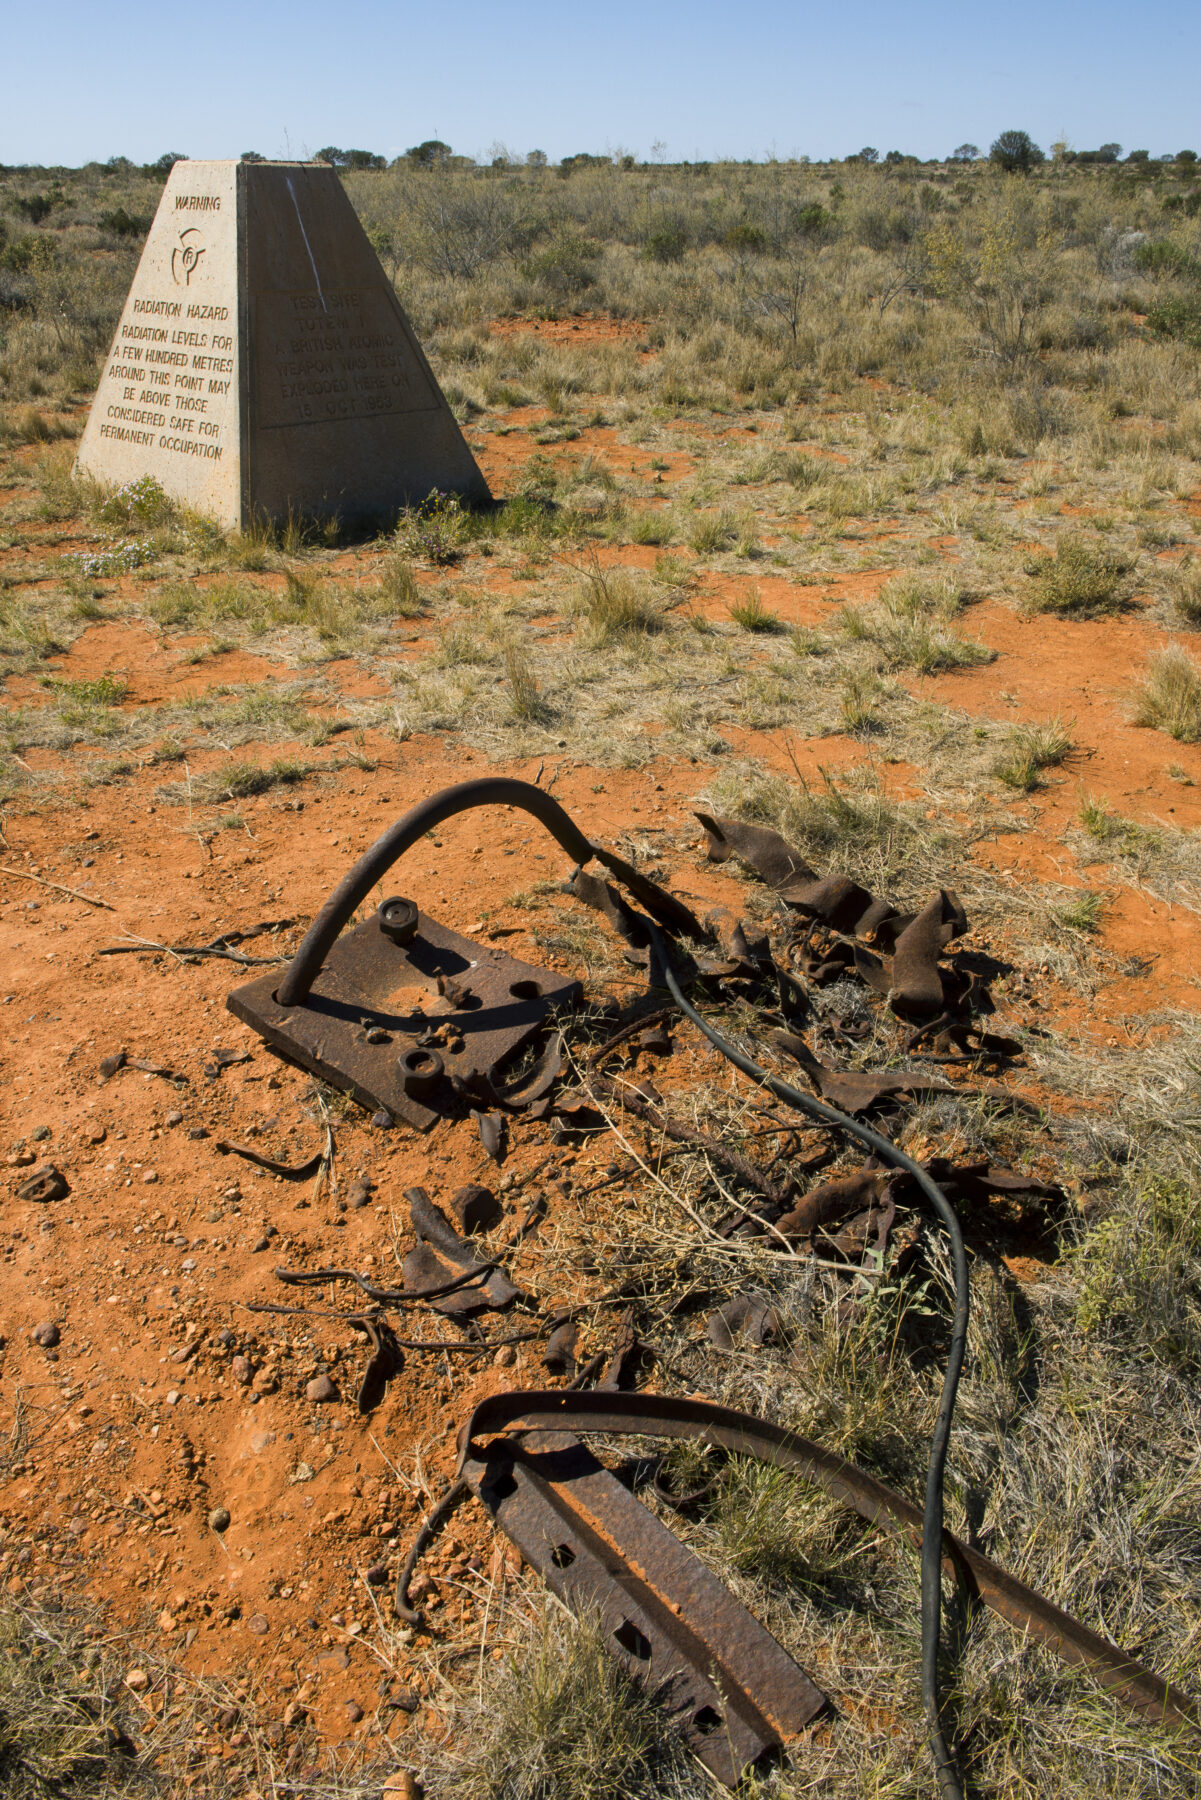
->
xmin=463 ymin=1433 xmax=826 ymax=1787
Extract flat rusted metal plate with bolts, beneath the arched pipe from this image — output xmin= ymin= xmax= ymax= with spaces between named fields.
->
xmin=227 ymin=900 xmax=580 ymax=1130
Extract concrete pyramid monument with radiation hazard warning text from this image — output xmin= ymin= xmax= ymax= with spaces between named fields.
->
xmin=77 ymin=162 xmax=488 ymax=529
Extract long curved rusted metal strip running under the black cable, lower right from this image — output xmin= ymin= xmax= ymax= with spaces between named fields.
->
xmin=459 ymin=1390 xmax=1201 ymax=1737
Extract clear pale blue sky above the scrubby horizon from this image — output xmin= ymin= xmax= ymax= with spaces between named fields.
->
xmin=0 ymin=0 xmax=1201 ymax=164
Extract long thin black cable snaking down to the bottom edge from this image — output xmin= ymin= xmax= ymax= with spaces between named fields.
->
xmin=643 ymin=918 xmax=971 ymax=1800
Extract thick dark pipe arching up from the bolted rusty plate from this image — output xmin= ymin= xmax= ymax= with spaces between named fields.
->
xmin=275 ymin=776 xmax=594 ymax=1006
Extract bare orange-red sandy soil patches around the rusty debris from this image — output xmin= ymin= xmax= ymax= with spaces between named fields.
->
xmin=0 ymin=376 xmax=1201 ymax=1741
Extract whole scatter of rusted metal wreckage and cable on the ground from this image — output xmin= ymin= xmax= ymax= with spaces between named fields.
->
xmin=77 ymin=778 xmax=1201 ymax=1796
